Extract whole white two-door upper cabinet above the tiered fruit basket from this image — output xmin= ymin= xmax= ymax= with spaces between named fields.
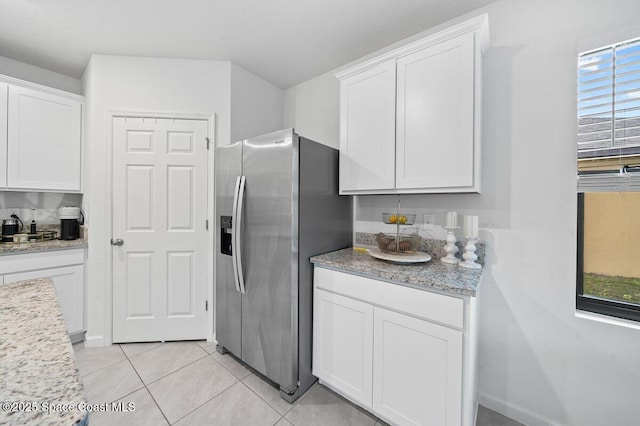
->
xmin=336 ymin=15 xmax=488 ymax=194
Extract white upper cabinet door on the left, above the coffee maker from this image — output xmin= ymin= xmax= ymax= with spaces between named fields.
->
xmin=7 ymin=86 xmax=82 ymax=191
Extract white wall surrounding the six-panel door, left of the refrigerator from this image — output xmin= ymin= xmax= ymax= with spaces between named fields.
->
xmin=83 ymin=55 xmax=231 ymax=346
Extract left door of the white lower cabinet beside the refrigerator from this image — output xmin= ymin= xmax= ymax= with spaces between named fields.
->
xmin=313 ymin=289 xmax=373 ymax=408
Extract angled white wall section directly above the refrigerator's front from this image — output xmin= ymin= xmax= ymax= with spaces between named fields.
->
xmin=230 ymin=64 xmax=283 ymax=142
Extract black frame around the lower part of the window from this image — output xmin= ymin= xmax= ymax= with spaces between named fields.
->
xmin=576 ymin=192 xmax=640 ymax=322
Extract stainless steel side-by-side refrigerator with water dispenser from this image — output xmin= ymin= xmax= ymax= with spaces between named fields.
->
xmin=215 ymin=129 xmax=352 ymax=402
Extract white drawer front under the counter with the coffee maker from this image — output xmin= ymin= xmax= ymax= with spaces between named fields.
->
xmin=0 ymin=249 xmax=84 ymax=274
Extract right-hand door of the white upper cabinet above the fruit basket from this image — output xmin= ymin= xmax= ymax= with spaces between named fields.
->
xmin=396 ymin=33 xmax=477 ymax=191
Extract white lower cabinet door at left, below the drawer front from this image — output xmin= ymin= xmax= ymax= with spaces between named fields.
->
xmin=4 ymin=265 xmax=84 ymax=334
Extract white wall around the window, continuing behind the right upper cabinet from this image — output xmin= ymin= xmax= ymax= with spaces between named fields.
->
xmin=285 ymin=0 xmax=640 ymax=426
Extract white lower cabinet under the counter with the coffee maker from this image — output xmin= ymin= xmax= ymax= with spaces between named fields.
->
xmin=0 ymin=249 xmax=84 ymax=341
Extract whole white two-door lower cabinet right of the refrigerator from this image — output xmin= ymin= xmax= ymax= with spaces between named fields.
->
xmin=313 ymin=267 xmax=477 ymax=426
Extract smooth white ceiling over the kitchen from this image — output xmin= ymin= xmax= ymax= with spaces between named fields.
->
xmin=0 ymin=0 xmax=494 ymax=89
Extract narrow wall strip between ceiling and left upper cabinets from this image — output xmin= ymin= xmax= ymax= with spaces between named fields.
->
xmin=0 ymin=56 xmax=83 ymax=95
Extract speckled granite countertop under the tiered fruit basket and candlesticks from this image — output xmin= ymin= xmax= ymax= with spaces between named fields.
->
xmin=311 ymin=248 xmax=482 ymax=296
